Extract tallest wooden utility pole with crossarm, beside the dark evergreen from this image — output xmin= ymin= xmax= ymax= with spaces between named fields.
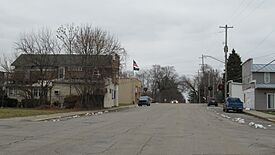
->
xmin=220 ymin=25 xmax=233 ymax=102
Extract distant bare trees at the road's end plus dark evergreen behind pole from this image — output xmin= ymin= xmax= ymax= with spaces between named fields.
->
xmin=126 ymin=49 xmax=242 ymax=103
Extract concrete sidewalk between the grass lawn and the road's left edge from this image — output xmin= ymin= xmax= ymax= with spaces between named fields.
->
xmin=2 ymin=105 xmax=137 ymax=121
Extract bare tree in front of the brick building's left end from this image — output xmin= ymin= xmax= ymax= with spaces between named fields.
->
xmin=15 ymin=29 xmax=60 ymax=104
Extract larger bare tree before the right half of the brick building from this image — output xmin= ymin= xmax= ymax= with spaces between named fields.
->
xmin=57 ymin=25 xmax=126 ymax=108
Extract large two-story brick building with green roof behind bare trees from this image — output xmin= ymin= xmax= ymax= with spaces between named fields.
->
xmin=8 ymin=54 xmax=120 ymax=107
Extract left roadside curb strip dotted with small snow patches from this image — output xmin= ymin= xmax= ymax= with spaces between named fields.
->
xmin=32 ymin=105 xmax=136 ymax=122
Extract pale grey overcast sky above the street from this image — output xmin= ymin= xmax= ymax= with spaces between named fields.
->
xmin=0 ymin=0 xmax=275 ymax=76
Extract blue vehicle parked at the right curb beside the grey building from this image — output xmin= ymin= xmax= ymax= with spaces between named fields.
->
xmin=223 ymin=97 xmax=243 ymax=112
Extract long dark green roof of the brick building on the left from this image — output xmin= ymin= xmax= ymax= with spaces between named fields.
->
xmin=11 ymin=54 xmax=118 ymax=67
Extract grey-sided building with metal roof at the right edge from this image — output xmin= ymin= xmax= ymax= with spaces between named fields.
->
xmin=242 ymin=59 xmax=275 ymax=110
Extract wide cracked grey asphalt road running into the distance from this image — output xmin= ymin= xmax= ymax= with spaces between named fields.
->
xmin=0 ymin=104 xmax=275 ymax=155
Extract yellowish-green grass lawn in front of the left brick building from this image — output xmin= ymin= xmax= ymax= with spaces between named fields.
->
xmin=0 ymin=108 xmax=73 ymax=118
